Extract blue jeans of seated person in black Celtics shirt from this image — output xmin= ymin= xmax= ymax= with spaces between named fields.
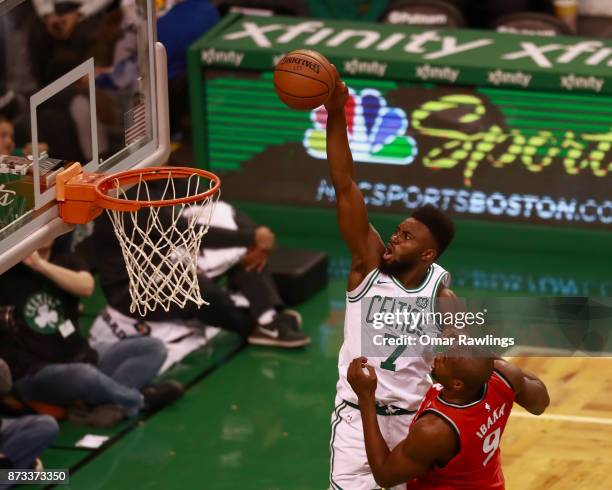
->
xmin=15 ymin=337 xmax=166 ymax=417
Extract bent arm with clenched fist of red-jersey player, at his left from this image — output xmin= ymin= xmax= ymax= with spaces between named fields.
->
xmin=348 ymin=358 xmax=459 ymax=488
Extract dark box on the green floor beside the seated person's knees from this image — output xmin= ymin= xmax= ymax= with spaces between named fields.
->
xmin=268 ymin=248 xmax=328 ymax=306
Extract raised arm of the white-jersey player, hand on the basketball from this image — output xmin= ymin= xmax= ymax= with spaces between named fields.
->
xmin=325 ymin=72 xmax=384 ymax=290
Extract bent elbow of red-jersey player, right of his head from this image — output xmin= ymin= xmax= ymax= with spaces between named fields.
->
xmin=495 ymin=359 xmax=550 ymax=415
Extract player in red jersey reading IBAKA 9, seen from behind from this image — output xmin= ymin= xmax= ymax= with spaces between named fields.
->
xmin=348 ymin=347 xmax=550 ymax=490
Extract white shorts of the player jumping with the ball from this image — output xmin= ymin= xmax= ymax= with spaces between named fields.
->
xmin=329 ymin=397 xmax=414 ymax=490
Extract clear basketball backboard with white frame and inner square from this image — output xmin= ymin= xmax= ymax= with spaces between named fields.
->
xmin=0 ymin=0 xmax=169 ymax=273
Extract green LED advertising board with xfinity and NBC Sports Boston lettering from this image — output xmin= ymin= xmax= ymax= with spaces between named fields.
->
xmin=190 ymin=17 xmax=612 ymax=228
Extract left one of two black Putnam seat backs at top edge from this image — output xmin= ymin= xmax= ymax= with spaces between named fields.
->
xmin=380 ymin=0 xmax=467 ymax=27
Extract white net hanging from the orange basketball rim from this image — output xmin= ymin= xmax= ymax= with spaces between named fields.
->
xmin=107 ymin=174 xmax=219 ymax=316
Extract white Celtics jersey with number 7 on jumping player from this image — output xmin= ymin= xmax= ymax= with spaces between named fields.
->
xmin=336 ymin=264 xmax=450 ymax=410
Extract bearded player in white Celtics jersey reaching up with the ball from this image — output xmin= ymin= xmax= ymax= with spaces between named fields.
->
xmin=325 ymin=72 xmax=456 ymax=490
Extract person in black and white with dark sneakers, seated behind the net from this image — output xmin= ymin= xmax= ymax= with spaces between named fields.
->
xmin=93 ymin=191 xmax=310 ymax=348
